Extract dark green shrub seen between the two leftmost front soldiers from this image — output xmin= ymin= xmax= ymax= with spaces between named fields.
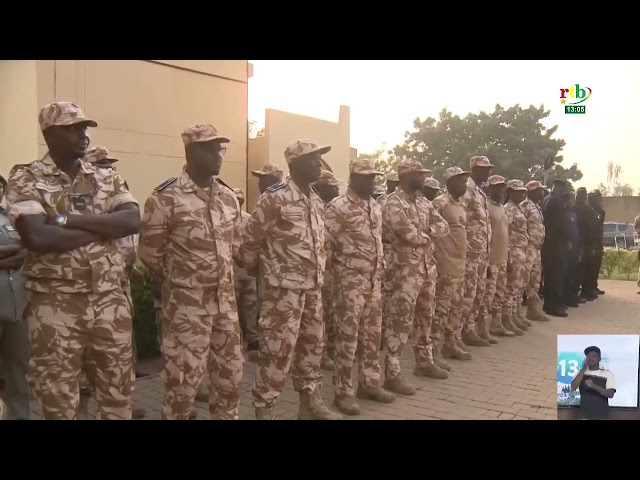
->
xmin=131 ymin=267 xmax=160 ymax=359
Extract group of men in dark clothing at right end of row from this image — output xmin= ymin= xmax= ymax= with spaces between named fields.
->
xmin=542 ymin=180 xmax=605 ymax=317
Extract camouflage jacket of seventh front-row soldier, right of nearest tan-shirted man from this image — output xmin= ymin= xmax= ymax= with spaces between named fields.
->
xmin=464 ymin=178 xmax=491 ymax=254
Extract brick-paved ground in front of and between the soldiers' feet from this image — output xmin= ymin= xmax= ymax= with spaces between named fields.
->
xmin=7 ymin=281 xmax=640 ymax=420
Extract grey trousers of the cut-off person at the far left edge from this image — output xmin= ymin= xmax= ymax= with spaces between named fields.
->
xmin=0 ymin=321 xmax=31 ymax=420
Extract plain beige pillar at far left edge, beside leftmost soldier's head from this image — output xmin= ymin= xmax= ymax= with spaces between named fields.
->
xmin=0 ymin=60 xmax=39 ymax=178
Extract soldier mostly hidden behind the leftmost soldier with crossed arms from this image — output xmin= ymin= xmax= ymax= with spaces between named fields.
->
xmin=77 ymin=146 xmax=146 ymax=420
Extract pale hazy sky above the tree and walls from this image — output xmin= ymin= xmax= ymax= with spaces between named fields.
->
xmin=249 ymin=60 xmax=640 ymax=191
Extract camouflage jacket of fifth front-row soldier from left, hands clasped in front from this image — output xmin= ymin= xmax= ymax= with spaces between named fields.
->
xmin=383 ymin=189 xmax=449 ymax=267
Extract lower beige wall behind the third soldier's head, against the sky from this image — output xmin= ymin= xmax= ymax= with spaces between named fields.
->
xmin=247 ymin=105 xmax=357 ymax=210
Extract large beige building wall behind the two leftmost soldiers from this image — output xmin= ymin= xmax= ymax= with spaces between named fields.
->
xmin=0 ymin=60 xmax=248 ymax=208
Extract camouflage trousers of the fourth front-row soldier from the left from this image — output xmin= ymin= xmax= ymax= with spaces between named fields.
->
xmin=333 ymin=268 xmax=382 ymax=397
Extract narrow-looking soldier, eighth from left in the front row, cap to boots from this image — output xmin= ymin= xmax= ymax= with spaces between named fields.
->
xmin=477 ymin=175 xmax=520 ymax=343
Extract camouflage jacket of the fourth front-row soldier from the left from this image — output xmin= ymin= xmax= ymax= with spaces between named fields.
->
xmin=325 ymin=189 xmax=384 ymax=280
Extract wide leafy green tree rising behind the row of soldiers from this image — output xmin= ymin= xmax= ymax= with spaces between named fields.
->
xmin=394 ymin=105 xmax=582 ymax=182
